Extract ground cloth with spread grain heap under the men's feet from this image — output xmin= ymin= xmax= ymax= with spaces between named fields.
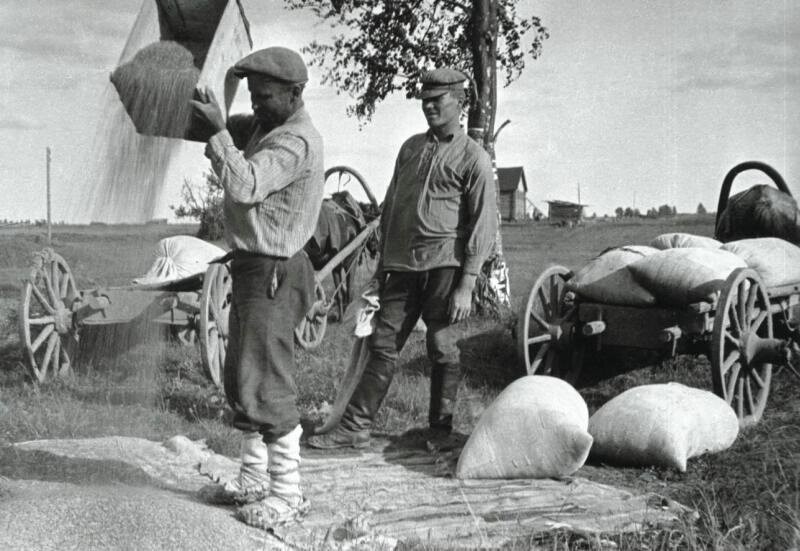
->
xmin=0 ymin=437 xmax=692 ymax=549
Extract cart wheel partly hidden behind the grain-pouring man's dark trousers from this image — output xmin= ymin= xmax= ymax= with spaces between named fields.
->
xmin=200 ymin=264 xmax=233 ymax=388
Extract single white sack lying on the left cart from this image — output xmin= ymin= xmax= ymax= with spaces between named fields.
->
xmin=133 ymin=235 xmax=225 ymax=285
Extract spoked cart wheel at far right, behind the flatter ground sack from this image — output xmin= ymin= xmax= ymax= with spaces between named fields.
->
xmin=711 ymin=268 xmax=772 ymax=428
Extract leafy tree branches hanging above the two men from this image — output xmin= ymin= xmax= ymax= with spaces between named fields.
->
xmin=285 ymin=0 xmax=549 ymax=122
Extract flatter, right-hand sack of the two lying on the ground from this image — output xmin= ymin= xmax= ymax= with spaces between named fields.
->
xmin=589 ymin=383 xmax=739 ymax=472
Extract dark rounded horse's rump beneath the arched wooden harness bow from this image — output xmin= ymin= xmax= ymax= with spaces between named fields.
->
xmin=716 ymin=185 xmax=800 ymax=245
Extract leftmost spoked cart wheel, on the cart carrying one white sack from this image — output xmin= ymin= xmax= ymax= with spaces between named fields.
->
xmin=19 ymin=249 xmax=80 ymax=383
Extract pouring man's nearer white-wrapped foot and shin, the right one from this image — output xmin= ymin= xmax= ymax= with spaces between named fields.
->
xmin=236 ymin=425 xmax=309 ymax=530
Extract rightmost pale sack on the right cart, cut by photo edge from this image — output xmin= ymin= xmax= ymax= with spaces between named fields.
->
xmin=722 ymin=237 xmax=800 ymax=287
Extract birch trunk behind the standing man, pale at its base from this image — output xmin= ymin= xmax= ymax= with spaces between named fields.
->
xmin=467 ymin=0 xmax=511 ymax=311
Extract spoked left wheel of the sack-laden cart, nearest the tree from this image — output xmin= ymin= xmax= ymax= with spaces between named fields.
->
xmin=517 ymin=266 xmax=584 ymax=384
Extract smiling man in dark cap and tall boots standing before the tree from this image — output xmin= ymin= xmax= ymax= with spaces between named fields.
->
xmin=308 ymin=68 xmax=497 ymax=449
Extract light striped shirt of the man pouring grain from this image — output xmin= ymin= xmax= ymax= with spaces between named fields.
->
xmin=206 ymin=107 xmax=325 ymax=258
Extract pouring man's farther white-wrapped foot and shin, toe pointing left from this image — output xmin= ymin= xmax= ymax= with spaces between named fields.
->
xmin=198 ymin=432 xmax=269 ymax=505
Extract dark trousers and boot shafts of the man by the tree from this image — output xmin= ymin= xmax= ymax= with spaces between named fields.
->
xmin=341 ymin=267 xmax=460 ymax=431
